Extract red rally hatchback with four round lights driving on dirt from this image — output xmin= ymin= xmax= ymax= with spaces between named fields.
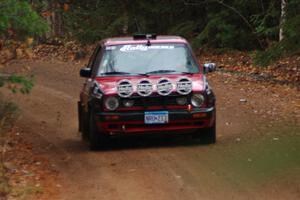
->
xmin=78 ymin=34 xmax=216 ymax=149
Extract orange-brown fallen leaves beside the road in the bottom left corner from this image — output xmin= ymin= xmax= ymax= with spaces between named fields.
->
xmin=4 ymin=128 xmax=60 ymax=200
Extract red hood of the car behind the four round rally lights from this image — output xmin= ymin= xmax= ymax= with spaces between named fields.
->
xmin=95 ymin=74 xmax=205 ymax=95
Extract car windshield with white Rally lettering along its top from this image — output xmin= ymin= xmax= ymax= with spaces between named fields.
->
xmin=98 ymin=43 xmax=199 ymax=76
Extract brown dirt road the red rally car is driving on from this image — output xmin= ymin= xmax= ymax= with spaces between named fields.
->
xmin=2 ymin=61 xmax=300 ymax=200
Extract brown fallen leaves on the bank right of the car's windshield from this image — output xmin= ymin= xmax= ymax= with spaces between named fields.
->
xmin=198 ymin=50 xmax=300 ymax=88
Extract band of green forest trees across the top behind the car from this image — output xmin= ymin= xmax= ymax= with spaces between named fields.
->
xmin=0 ymin=0 xmax=300 ymax=64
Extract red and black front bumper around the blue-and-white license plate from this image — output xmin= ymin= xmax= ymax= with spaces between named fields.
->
xmin=96 ymin=107 xmax=216 ymax=135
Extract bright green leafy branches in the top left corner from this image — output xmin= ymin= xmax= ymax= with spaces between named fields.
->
xmin=0 ymin=0 xmax=48 ymax=39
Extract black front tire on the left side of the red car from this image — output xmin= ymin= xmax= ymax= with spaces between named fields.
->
xmin=88 ymin=110 xmax=108 ymax=151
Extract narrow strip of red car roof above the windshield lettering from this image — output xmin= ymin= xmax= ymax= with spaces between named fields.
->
xmin=101 ymin=35 xmax=187 ymax=46
